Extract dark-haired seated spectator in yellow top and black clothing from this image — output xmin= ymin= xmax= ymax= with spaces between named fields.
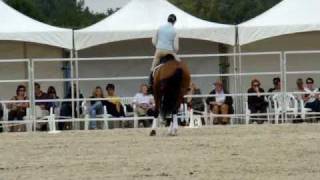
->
xmin=104 ymin=84 xmax=125 ymax=117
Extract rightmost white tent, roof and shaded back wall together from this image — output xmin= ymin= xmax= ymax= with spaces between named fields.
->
xmin=239 ymin=0 xmax=320 ymax=92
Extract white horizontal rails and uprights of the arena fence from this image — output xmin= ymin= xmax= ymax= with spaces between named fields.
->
xmin=0 ymin=51 xmax=320 ymax=132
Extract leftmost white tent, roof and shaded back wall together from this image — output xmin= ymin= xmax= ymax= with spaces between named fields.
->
xmin=0 ymin=1 xmax=73 ymax=99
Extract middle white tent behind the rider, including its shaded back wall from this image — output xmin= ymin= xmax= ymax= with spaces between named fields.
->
xmin=75 ymin=0 xmax=235 ymax=96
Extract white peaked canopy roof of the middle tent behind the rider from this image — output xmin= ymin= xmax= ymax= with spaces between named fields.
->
xmin=75 ymin=0 xmax=235 ymax=50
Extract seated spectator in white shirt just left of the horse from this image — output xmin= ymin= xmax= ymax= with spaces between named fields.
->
xmin=133 ymin=84 xmax=154 ymax=127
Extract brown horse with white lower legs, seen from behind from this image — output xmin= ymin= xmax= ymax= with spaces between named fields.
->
xmin=150 ymin=54 xmax=191 ymax=136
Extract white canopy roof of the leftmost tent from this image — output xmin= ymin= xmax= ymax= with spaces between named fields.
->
xmin=0 ymin=1 xmax=73 ymax=49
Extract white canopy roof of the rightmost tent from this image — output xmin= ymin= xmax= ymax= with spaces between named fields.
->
xmin=238 ymin=0 xmax=320 ymax=45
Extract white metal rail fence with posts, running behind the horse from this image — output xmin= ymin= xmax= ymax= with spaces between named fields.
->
xmin=0 ymin=51 xmax=320 ymax=131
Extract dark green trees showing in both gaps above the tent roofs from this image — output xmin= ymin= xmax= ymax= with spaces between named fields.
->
xmin=4 ymin=0 xmax=281 ymax=29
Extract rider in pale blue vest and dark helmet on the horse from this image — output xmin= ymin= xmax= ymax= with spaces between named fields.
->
xmin=150 ymin=14 xmax=180 ymax=93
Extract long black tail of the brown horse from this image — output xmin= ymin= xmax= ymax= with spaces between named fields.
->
xmin=160 ymin=68 xmax=183 ymax=117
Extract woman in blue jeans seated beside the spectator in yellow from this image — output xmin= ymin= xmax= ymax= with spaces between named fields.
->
xmin=89 ymin=86 xmax=104 ymax=129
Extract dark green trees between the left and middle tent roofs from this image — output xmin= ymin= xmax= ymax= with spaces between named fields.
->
xmin=5 ymin=0 xmax=110 ymax=29
